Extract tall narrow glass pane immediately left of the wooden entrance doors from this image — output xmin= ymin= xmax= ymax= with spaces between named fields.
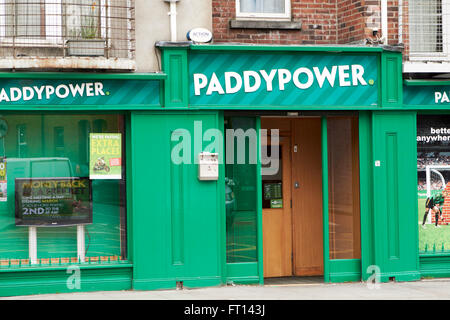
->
xmin=225 ymin=117 xmax=258 ymax=263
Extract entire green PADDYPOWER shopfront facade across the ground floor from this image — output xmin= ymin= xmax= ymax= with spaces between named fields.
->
xmin=0 ymin=44 xmax=450 ymax=296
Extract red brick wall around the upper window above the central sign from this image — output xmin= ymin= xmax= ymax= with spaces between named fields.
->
xmin=212 ymin=0 xmax=384 ymax=45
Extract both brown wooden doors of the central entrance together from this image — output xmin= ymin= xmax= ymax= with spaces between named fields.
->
xmin=261 ymin=117 xmax=323 ymax=277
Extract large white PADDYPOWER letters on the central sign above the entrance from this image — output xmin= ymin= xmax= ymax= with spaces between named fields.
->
xmin=194 ymin=64 xmax=367 ymax=96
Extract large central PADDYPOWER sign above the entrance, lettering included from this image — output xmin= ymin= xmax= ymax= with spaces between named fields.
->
xmin=189 ymin=52 xmax=379 ymax=108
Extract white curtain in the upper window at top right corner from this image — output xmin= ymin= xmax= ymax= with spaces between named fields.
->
xmin=409 ymin=0 xmax=442 ymax=53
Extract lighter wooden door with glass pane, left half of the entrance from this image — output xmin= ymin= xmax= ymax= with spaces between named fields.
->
xmin=262 ymin=137 xmax=292 ymax=277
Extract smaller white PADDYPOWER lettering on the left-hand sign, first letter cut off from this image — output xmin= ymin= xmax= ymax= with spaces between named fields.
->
xmin=0 ymin=82 xmax=105 ymax=102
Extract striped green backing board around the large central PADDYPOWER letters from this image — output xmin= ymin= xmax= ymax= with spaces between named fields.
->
xmin=188 ymin=47 xmax=382 ymax=110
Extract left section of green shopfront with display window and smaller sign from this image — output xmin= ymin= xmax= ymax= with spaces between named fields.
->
xmin=0 ymin=73 xmax=165 ymax=296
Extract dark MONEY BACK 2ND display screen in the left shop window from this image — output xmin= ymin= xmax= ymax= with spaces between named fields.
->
xmin=15 ymin=177 xmax=92 ymax=226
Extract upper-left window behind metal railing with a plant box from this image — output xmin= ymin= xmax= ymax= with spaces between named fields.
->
xmin=0 ymin=0 xmax=134 ymax=63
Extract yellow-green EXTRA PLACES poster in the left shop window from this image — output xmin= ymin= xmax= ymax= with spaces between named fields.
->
xmin=89 ymin=133 xmax=122 ymax=179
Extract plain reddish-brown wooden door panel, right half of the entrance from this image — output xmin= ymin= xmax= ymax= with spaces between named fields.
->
xmin=291 ymin=117 xmax=323 ymax=276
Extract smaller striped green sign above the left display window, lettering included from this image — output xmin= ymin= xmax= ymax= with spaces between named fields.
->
xmin=0 ymin=79 xmax=160 ymax=108
